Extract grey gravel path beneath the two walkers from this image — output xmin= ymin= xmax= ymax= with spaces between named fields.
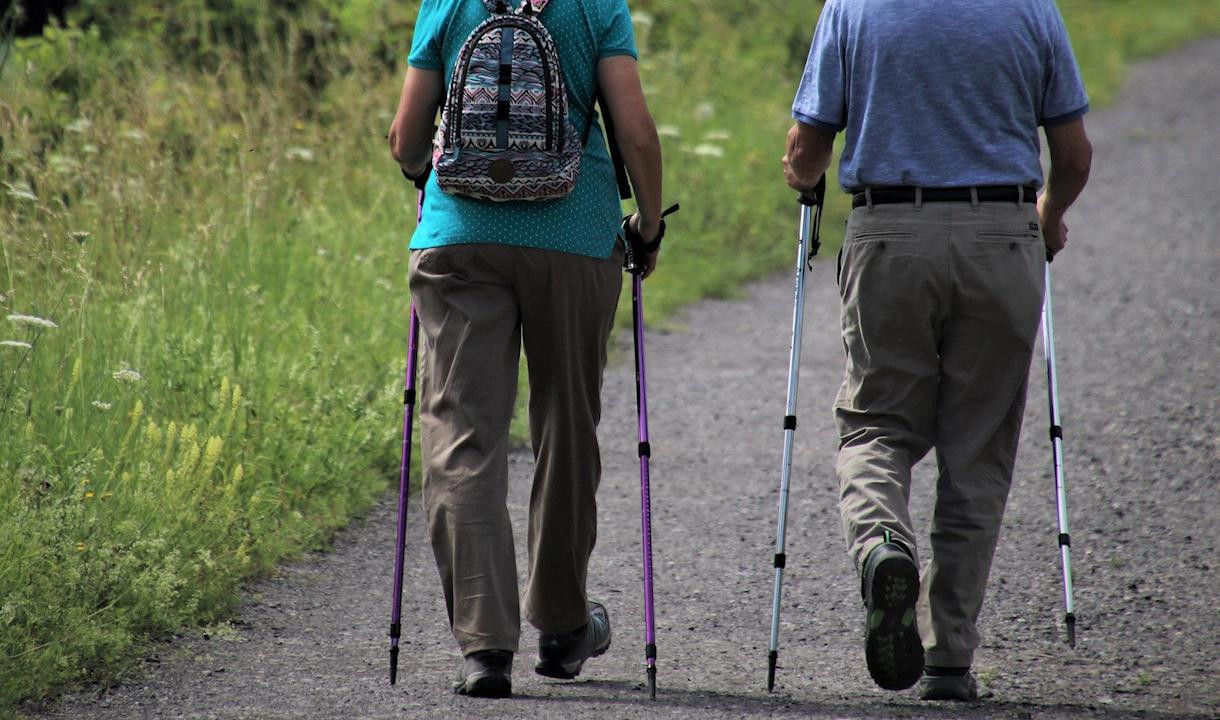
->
xmin=30 ymin=39 xmax=1220 ymax=719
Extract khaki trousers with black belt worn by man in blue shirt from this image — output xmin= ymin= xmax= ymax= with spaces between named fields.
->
xmin=834 ymin=203 xmax=1046 ymax=666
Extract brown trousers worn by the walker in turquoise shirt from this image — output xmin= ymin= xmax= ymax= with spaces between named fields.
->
xmin=409 ymin=244 xmax=622 ymax=654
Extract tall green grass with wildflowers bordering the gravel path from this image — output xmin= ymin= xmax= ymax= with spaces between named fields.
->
xmin=0 ymin=0 xmax=1220 ymax=709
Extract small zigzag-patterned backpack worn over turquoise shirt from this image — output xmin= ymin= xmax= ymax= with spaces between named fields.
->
xmin=432 ymin=0 xmax=584 ymax=201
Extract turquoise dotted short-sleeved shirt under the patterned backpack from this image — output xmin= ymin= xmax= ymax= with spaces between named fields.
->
xmin=407 ymin=0 xmax=638 ymax=257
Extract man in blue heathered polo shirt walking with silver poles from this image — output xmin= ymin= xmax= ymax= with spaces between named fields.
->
xmin=783 ymin=0 xmax=1092 ymax=700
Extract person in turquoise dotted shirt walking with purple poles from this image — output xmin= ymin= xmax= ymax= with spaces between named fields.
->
xmin=389 ymin=0 xmax=661 ymax=697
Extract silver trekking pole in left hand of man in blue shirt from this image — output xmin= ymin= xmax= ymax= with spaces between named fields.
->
xmin=766 ymin=175 xmax=826 ymax=692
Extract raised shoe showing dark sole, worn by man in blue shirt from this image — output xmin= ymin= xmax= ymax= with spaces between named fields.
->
xmin=861 ymin=542 xmax=924 ymax=689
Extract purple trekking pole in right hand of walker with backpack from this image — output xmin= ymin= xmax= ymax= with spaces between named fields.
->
xmin=622 ymin=205 xmax=678 ymax=700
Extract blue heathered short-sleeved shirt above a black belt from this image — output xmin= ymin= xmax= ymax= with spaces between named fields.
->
xmin=792 ymin=0 xmax=1088 ymax=192
